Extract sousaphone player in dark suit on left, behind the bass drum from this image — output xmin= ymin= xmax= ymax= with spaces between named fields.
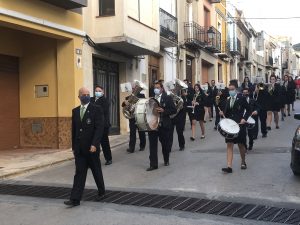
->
xmin=122 ymin=85 xmax=146 ymax=153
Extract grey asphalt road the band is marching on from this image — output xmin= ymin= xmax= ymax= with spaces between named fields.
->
xmin=0 ymin=103 xmax=300 ymax=224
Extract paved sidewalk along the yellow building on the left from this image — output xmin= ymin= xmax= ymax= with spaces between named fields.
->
xmin=0 ymin=135 xmax=128 ymax=179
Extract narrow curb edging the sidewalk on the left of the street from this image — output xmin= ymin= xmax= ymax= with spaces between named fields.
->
xmin=0 ymin=141 xmax=127 ymax=181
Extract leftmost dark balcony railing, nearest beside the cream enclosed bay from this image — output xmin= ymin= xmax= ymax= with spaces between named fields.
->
xmin=159 ymin=9 xmax=178 ymax=43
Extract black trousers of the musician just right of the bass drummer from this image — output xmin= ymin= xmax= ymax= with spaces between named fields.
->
xmin=170 ymin=110 xmax=186 ymax=151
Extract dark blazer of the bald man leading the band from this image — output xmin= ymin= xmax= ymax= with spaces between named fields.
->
xmin=72 ymin=103 xmax=104 ymax=155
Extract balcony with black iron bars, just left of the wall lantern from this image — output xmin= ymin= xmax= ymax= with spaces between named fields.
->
xmin=184 ymin=22 xmax=206 ymax=49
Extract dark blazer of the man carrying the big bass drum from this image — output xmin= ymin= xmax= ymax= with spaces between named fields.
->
xmin=159 ymin=92 xmax=177 ymax=129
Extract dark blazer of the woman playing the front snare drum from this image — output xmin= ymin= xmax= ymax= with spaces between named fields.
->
xmin=222 ymin=95 xmax=251 ymax=123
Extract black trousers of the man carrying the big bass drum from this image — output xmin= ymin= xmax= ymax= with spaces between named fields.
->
xmin=148 ymin=127 xmax=171 ymax=167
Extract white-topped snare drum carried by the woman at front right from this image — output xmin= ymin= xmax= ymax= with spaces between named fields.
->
xmin=218 ymin=119 xmax=240 ymax=139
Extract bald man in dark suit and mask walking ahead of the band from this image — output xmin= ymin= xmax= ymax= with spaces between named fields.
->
xmin=64 ymin=88 xmax=105 ymax=206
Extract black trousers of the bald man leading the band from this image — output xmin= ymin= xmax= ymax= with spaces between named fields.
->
xmin=70 ymin=150 xmax=105 ymax=201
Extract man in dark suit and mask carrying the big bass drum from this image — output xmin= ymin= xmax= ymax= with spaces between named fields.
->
xmin=147 ymin=82 xmax=176 ymax=171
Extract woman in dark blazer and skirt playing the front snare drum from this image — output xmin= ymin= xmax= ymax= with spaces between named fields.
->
xmin=220 ymin=81 xmax=250 ymax=173
